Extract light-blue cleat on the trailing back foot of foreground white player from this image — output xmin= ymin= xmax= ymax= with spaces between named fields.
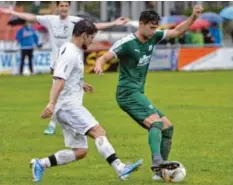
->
xmin=30 ymin=159 xmax=45 ymax=182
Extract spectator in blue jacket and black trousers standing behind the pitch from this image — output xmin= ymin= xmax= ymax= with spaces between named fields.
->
xmin=16 ymin=21 xmax=39 ymax=75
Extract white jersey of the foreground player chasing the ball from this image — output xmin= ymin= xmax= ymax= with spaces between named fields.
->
xmin=54 ymin=42 xmax=84 ymax=112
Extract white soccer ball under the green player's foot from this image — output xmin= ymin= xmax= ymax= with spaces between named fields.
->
xmin=162 ymin=161 xmax=186 ymax=182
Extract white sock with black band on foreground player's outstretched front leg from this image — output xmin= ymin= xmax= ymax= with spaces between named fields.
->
xmin=95 ymin=136 xmax=125 ymax=174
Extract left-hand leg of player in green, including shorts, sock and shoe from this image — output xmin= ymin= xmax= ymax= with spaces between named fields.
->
xmin=117 ymin=92 xmax=177 ymax=171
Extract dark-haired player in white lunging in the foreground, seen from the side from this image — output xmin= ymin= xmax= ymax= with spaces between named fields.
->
xmin=31 ymin=20 xmax=142 ymax=182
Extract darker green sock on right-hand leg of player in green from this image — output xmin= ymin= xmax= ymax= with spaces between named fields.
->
xmin=160 ymin=126 xmax=174 ymax=161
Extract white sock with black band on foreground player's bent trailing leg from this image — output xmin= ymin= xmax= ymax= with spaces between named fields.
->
xmin=40 ymin=150 xmax=76 ymax=168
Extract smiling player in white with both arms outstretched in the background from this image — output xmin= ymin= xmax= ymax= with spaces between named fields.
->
xmin=0 ymin=1 xmax=127 ymax=135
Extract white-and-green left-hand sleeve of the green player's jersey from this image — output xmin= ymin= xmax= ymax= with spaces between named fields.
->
xmin=109 ymin=40 xmax=127 ymax=58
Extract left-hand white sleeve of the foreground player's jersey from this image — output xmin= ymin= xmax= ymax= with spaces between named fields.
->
xmin=53 ymin=47 xmax=75 ymax=80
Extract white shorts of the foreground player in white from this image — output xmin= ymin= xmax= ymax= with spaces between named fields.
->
xmin=56 ymin=106 xmax=99 ymax=148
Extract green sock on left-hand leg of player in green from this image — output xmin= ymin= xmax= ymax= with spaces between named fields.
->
xmin=148 ymin=121 xmax=163 ymax=160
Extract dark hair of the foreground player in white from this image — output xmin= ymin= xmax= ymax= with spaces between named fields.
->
xmin=73 ymin=19 xmax=97 ymax=37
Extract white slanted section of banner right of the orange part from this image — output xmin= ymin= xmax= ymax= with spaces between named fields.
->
xmin=182 ymin=48 xmax=233 ymax=71
